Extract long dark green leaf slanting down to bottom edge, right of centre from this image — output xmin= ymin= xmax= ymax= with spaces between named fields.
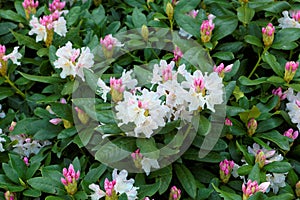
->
xmin=175 ymin=164 xmax=197 ymax=199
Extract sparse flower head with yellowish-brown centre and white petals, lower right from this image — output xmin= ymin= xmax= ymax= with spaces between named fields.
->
xmin=248 ymin=143 xmax=283 ymax=168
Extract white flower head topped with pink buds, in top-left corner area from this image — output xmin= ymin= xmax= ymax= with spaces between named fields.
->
xmin=28 ymin=10 xmax=67 ymax=47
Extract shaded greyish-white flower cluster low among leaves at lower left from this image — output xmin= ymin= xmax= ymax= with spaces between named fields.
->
xmin=9 ymin=134 xmax=51 ymax=157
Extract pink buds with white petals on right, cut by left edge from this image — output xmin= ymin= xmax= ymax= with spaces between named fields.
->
xmin=0 ymin=45 xmax=22 ymax=76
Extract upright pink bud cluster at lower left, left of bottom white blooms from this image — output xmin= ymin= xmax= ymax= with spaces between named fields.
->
xmin=61 ymin=164 xmax=80 ymax=195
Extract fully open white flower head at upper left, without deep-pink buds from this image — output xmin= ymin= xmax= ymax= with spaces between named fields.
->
xmin=54 ymin=41 xmax=94 ymax=81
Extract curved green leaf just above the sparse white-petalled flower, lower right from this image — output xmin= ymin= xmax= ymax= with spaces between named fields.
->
xmin=256 ymin=130 xmax=290 ymax=151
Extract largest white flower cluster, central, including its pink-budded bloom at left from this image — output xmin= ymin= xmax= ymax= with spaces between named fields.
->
xmin=98 ymin=60 xmax=223 ymax=138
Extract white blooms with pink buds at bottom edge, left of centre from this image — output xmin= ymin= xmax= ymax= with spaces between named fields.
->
xmin=89 ymin=169 xmax=139 ymax=200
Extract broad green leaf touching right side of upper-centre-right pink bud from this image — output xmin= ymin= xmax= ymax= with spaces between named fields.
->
xmin=212 ymin=16 xmax=238 ymax=41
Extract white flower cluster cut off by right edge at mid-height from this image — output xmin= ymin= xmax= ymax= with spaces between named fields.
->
xmin=286 ymin=88 xmax=300 ymax=131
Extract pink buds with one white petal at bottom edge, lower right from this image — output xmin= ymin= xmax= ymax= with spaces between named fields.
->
xmin=242 ymin=180 xmax=270 ymax=200
